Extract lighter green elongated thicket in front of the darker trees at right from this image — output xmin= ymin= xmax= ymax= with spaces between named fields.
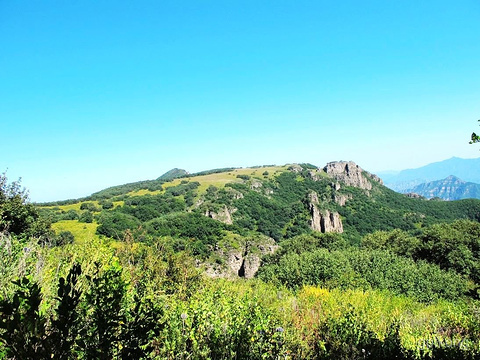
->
xmin=257 ymin=246 xmax=472 ymax=302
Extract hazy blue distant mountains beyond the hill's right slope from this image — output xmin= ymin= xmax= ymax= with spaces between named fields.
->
xmin=378 ymin=157 xmax=480 ymax=200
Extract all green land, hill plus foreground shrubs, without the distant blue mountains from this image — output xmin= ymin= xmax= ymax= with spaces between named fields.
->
xmin=0 ymin=162 xmax=480 ymax=359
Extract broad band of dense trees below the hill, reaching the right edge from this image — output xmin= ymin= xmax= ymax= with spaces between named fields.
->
xmin=258 ymin=220 xmax=480 ymax=302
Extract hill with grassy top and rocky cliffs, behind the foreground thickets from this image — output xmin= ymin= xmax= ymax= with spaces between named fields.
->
xmin=43 ymin=161 xmax=480 ymax=277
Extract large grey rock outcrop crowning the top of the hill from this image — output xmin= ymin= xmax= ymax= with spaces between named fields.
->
xmin=323 ymin=161 xmax=383 ymax=190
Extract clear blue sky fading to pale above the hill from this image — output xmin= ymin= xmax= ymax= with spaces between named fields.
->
xmin=0 ymin=0 xmax=480 ymax=201
